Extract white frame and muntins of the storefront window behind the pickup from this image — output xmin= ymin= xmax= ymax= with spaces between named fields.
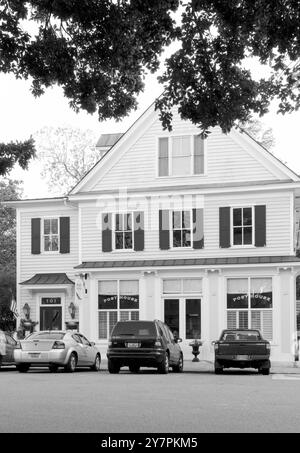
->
xmin=224 ymin=275 xmax=274 ymax=342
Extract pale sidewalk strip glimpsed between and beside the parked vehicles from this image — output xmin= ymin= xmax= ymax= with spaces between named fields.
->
xmin=101 ymin=357 xmax=300 ymax=375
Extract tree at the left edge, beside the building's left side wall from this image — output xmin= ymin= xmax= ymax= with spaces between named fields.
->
xmin=0 ymin=179 xmax=22 ymax=305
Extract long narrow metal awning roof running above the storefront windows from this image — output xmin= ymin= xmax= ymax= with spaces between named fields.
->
xmin=75 ymin=255 xmax=300 ymax=269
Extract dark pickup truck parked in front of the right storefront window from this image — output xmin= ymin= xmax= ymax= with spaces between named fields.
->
xmin=213 ymin=329 xmax=271 ymax=375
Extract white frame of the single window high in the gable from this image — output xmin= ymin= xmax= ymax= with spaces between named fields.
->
xmin=156 ymin=133 xmax=207 ymax=178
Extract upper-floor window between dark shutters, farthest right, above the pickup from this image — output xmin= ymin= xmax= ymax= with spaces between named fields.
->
xmin=232 ymin=207 xmax=254 ymax=245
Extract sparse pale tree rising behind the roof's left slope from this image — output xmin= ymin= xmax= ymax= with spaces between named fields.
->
xmin=34 ymin=127 xmax=99 ymax=196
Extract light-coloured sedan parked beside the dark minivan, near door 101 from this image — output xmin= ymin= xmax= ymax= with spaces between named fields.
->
xmin=14 ymin=330 xmax=101 ymax=373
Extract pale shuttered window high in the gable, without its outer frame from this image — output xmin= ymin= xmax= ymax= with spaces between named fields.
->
xmin=158 ymin=135 xmax=204 ymax=176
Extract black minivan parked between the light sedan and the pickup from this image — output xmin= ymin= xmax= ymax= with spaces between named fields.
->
xmin=107 ymin=320 xmax=183 ymax=374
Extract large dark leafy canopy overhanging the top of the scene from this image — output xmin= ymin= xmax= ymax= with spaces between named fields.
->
xmin=0 ymin=0 xmax=300 ymax=170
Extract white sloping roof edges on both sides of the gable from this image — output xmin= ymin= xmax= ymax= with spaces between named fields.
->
xmin=68 ymin=101 xmax=300 ymax=195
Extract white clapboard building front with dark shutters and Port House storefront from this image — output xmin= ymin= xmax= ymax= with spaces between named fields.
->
xmin=10 ymin=106 xmax=300 ymax=362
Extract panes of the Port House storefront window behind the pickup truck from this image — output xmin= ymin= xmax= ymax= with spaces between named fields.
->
xmin=227 ymin=278 xmax=273 ymax=340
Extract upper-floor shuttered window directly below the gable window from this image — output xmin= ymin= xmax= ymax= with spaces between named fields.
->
xmin=171 ymin=211 xmax=192 ymax=247
